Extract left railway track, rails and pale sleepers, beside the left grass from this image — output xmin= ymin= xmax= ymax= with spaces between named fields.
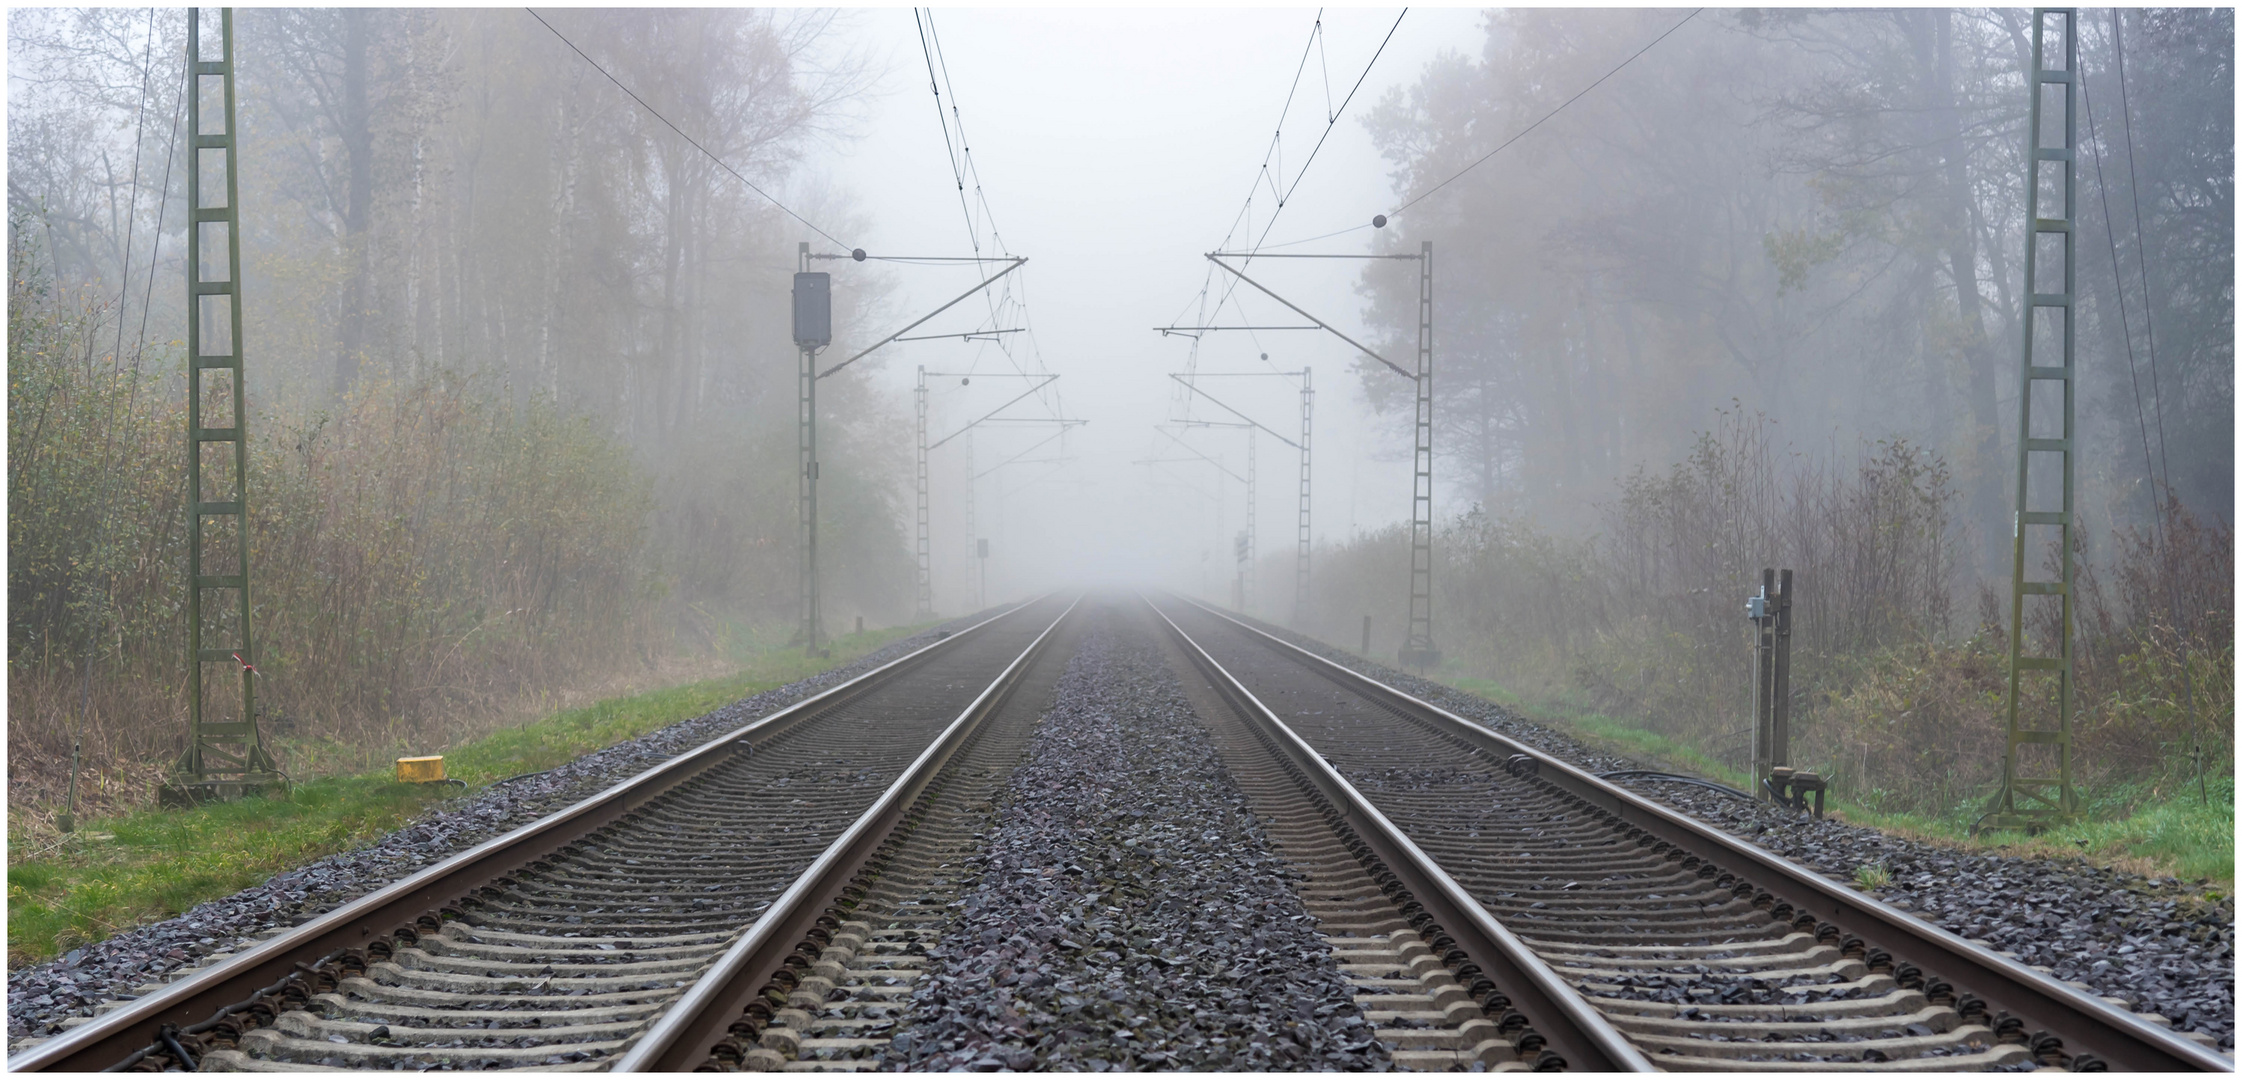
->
xmin=9 ymin=598 xmax=1072 ymax=1071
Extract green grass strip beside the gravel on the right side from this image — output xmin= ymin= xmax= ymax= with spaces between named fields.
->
xmin=1444 ymin=677 xmax=2235 ymax=894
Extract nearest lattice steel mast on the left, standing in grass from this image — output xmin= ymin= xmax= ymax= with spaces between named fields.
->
xmin=161 ymin=7 xmax=282 ymax=802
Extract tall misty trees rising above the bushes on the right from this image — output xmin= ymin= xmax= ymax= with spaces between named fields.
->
xmin=1356 ymin=9 xmax=2235 ymax=557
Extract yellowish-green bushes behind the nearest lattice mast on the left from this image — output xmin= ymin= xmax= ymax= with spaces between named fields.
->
xmin=9 ymin=231 xmax=659 ymax=820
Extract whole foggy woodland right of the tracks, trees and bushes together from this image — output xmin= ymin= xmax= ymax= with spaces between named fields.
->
xmin=1309 ymin=9 xmax=2235 ymax=811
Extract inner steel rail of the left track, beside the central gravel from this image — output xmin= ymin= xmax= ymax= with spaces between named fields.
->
xmin=610 ymin=596 xmax=1083 ymax=1073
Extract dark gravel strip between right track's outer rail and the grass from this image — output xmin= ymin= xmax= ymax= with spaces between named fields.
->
xmin=1256 ymin=623 xmax=2235 ymax=1055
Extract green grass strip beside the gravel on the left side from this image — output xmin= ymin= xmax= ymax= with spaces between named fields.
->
xmin=7 ymin=627 xmax=919 ymax=968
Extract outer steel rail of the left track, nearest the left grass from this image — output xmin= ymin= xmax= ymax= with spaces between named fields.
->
xmin=7 ymin=598 xmax=1040 ymax=1073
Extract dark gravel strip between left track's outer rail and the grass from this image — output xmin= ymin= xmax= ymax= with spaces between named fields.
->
xmin=7 ymin=614 xmax=986 ymax=1042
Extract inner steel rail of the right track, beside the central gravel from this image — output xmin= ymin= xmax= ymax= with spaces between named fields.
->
xmin=1139 ymin=594 xmax=1659 ymax=1073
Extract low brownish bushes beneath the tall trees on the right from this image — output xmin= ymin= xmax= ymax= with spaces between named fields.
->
xmin=1307 ymin=412 xmax=2235 ymax=816
